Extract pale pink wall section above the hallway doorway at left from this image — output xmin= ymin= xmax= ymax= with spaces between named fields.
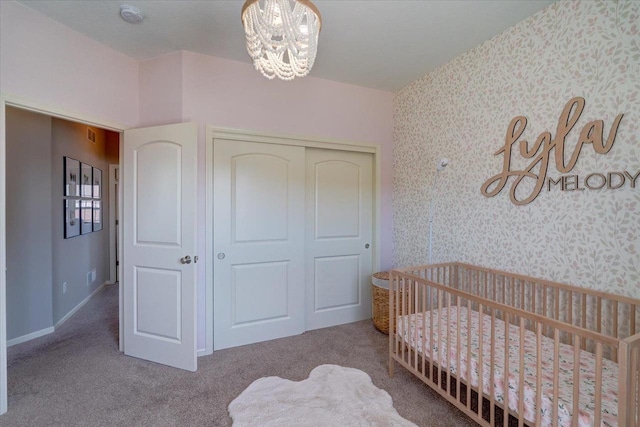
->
xmin=0 ymin=1 xmax=138 ymax=126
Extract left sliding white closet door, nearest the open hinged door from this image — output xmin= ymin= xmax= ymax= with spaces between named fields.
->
xmin=213 ymin=140 xmax=305 ymax=350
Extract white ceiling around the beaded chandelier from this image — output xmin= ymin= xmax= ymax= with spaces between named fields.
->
xmin=19 ymin=0 xmax=554 ymax=91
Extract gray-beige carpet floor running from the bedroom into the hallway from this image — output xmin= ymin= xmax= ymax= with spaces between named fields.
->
xmin=0 ymin=286 xmax=475 ymax=426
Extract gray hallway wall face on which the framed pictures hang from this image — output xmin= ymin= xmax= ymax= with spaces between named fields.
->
xmin=51 ymin=118 xmax=117 ymax=324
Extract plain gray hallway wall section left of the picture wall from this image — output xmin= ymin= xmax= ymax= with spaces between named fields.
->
xmin=6 ymin=108 xmax=53 ymax=339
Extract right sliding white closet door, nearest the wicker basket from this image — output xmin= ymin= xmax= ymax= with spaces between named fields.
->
xmin=306 ymin=148 xmax=373 ymax=330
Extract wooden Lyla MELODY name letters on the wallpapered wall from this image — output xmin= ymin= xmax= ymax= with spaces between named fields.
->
xmin=480 ymin=97 xmax=640 ymax=205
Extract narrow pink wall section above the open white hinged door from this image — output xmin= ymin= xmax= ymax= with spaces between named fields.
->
xmin=137 ymin=52 xmax=182 ymax=127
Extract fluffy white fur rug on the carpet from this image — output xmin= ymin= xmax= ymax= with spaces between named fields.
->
xmin=229 ymin=365 xmax=415 ymax=427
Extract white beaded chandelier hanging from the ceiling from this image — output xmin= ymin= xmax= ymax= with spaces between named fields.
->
xmin=241 ymin=0 xmax=322 ymax=80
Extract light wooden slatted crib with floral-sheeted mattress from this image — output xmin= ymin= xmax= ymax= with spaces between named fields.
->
xmin=389 ymin=263 xmax=640 ymax=426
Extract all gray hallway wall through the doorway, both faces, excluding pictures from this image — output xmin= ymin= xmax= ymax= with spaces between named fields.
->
xmin=7 ymin=108 xmax=118 ymax=339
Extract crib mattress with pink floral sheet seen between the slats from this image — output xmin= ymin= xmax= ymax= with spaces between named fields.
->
xmin=397 ymin=307 xmax=618 ymax=426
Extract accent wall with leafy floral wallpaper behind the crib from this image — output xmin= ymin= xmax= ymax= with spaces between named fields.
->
xmin=393 ymin=1 xmax=640 ymax=298
